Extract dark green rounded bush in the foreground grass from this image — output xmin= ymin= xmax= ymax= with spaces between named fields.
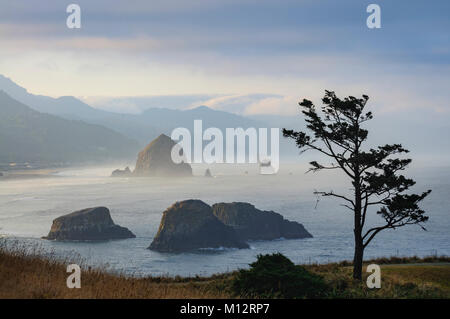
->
xmin=232 ymin=253 xmax=327 ymax=298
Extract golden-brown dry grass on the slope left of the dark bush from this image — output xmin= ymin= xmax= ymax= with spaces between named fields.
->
xmin=0 ymin=245 xmax=229 ymax=299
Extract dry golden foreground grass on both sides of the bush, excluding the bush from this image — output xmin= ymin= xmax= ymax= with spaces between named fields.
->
xmin=0 ymin=245 xmax=450 ymax=299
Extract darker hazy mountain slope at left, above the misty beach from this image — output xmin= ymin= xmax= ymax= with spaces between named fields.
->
xmin=0 ymin=90 xmax=138 ymax=164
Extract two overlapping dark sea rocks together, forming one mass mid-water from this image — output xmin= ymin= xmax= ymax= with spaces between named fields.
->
xmin=149 ymin=199 xmax=312 ymax=252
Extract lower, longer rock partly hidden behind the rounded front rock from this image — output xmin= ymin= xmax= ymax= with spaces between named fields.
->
xmin=212 ymin=202 xmax=312 ymax=240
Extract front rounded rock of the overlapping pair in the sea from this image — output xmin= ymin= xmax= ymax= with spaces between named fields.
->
xmin=149 ymin=199 xmax=249 ymax=252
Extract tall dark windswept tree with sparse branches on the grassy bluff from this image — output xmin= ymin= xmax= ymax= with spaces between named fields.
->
xmin=283 ymin=91 xmax=431 ymax=280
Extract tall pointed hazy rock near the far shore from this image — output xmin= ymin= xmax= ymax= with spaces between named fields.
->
xmin=133 ymin=134 xmax=192 ymax=177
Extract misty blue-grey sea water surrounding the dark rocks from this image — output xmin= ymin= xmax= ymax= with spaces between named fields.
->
xmin=0 ymin=164 xmax=450 ymax=276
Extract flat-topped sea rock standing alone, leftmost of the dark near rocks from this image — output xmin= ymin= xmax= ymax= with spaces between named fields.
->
xmin=42 ymin=207 xmax=136 ymax=241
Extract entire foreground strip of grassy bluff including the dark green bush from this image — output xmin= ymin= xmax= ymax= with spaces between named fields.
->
xmin=0 ymin=242 xmax=450 ymax=299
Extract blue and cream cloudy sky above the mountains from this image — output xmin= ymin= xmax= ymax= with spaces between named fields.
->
xmin=0 ymin=0 xmax=450 ymax=118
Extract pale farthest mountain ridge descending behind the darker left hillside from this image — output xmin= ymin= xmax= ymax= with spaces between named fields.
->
xmin=0 ymin=75 xmax=267 ymax=146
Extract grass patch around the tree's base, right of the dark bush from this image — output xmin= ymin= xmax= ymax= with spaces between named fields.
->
xmin=306 ymin=256 xmax=450 ymax=299
